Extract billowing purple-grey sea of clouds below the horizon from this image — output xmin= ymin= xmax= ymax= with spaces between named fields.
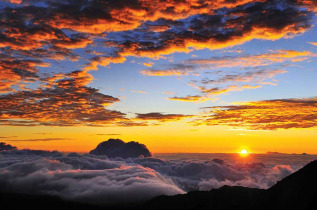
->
xmin=0 ymin=150 xmax=294 ymax=204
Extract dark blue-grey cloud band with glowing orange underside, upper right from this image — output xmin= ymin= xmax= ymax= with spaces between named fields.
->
xmin=108 ymin=1 xmax=312 ymax=61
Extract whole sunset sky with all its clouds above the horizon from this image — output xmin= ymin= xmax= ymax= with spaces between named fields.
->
xmin=0 ymin=0 xmax=317 ymax=154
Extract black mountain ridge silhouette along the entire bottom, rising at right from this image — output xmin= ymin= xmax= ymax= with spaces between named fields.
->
xmin=0 ymin=160 xmax=317 ymax=210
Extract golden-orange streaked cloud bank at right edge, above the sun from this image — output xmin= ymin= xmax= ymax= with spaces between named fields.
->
xmin=195 ymin=98 xmax=317 ymax=130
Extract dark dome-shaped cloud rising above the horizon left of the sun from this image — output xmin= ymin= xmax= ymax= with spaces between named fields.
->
xmin=89 ymin=139 xmax=152 ymax=158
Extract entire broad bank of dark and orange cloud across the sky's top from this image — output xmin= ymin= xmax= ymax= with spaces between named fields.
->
xmin=0 ymin=0 xmax=316 ymax=68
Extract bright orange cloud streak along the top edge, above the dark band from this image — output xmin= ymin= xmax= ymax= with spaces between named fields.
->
xmin=45 ymin=0 xmax=263 ymax=34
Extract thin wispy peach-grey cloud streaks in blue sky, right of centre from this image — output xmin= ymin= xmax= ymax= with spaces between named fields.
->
xmin=141 ymin=50 xmax=317 ymax=102
